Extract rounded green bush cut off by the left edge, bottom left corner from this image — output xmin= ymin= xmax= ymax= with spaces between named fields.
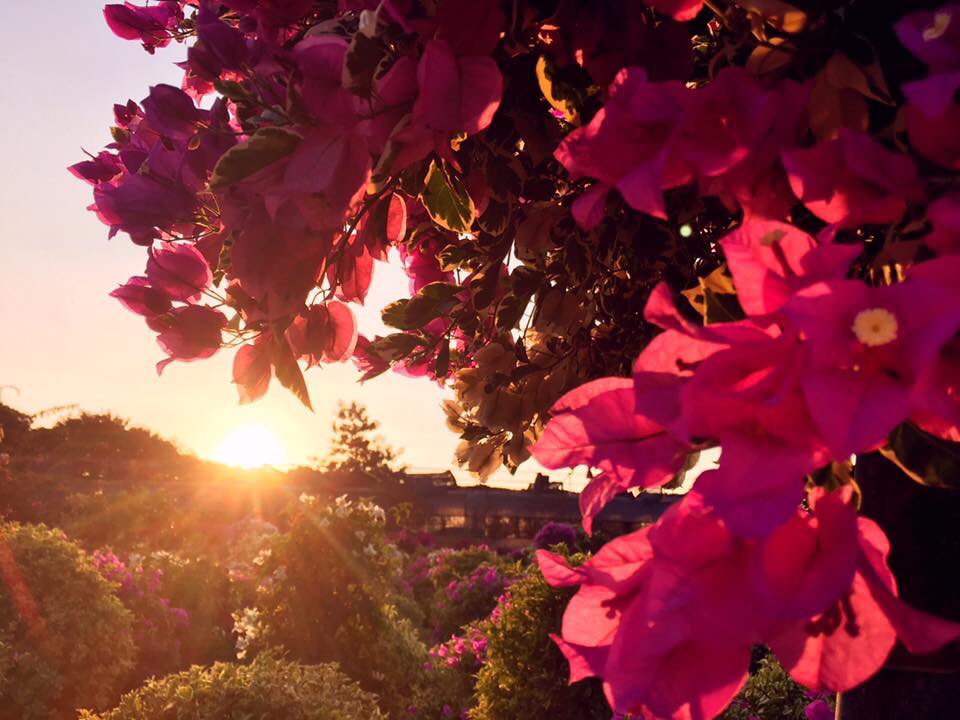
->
xmin=0 ymin=523 xmax=136 ymax=720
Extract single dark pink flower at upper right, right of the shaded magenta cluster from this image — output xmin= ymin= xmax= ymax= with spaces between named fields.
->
xmin=783 ymin=130 xmax=923 ymax=228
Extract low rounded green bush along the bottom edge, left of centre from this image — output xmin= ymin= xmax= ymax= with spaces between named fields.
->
xmin=80 ymin=654 xmax=384 ymax=720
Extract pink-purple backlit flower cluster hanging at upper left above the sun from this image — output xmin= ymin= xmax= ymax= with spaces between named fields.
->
xmin=77 ymin=0 xmax=506 ymax=394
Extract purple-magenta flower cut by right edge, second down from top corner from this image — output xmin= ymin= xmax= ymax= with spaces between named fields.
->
xmin=904 ymin=71 xmax=960 ymax=170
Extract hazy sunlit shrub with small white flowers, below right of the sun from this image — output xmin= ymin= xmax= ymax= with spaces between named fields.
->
xmin=235 ymin=496 xmax=426 ymax=717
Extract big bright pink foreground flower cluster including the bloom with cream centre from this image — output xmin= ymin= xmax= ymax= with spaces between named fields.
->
xmin=533 ymin=221 xmax=960 ymax=718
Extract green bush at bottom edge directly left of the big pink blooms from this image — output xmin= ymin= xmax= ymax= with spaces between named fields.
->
xmin=469 ymin=558 xmax=611 ymax=720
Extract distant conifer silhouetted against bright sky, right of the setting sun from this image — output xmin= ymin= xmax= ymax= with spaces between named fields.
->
xmin=321 ymin=402 xmax=405 ymax=482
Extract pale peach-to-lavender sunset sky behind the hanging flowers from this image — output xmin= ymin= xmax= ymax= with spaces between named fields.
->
xmin=0 ymin=0 xmax=577 ymax=486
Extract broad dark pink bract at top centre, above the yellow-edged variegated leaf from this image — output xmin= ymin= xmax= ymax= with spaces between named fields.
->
xmin=413 ymin=40 xmax=503 ymax=135
